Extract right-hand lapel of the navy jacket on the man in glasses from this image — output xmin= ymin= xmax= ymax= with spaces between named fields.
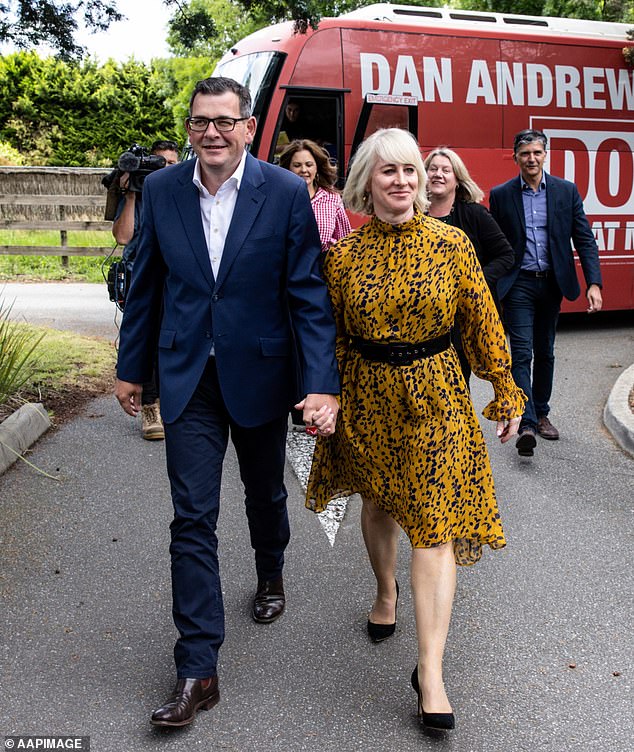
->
xmin=211 ymin=154 xmax=266 ymax=289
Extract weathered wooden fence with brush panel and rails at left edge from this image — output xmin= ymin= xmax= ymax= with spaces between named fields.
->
xmin=0 ymin=167 xmax=115 ymax=262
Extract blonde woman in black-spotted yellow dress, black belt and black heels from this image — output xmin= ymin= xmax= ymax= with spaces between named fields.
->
xmin=307 ymin=128 xmax=525 ymax=729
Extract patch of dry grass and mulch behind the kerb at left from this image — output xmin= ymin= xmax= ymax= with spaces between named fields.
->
xmin=0 ymin=324 xmax=116 ymax=425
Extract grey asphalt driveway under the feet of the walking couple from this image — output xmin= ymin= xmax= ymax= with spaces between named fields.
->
xmin=0 ymin=285 xmax=634 ymax=752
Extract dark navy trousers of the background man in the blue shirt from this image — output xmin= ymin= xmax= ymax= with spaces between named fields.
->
xmin=503 ymin=271 xmax=562 ymax=429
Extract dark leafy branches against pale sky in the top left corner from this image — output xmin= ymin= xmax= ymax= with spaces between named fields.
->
xmin=0 ymin=0 xmax=123 ymax=60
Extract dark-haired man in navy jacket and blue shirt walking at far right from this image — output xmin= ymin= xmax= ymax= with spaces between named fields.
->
xmin=490 ymin=130 xmax=602 ymax=457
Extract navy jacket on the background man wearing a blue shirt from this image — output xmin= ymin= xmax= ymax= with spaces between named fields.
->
xmin=489 ymin=173 xmax=601 ymax=300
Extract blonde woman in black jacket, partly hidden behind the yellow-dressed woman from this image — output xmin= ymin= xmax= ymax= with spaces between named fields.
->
xmin=424 ymin=147 xmax=515 ymax=384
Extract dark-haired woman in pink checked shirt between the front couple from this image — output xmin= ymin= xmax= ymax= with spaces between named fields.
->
xmin=280 ymin=139 xmax=352 ymax=252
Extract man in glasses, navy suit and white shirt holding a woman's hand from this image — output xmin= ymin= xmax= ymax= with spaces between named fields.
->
xmin=116 ymin=78 xmax=339 ymax=726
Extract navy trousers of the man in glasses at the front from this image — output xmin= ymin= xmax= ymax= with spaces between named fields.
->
xmin=165 ymin=358 xmax=290 ymax=679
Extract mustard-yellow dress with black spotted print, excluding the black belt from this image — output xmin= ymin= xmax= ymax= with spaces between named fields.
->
xmin=306 ymin=214 xmax=525 ymax=565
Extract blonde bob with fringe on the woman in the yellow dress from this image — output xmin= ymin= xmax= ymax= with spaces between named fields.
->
xmin=343 ymin=128 xmax=429 ymax=216
